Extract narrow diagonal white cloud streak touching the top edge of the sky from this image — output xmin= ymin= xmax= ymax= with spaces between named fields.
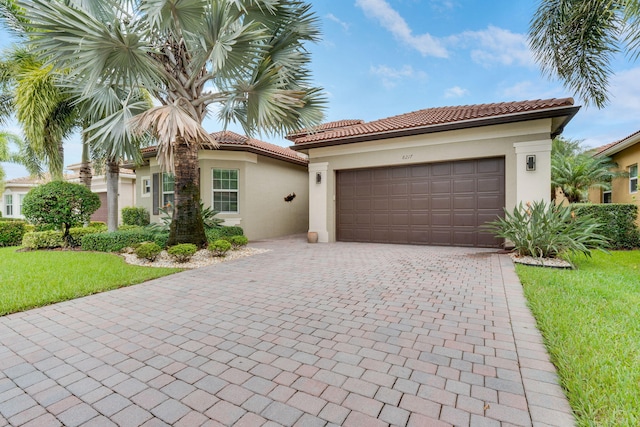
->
xmin=356 ymin=0 xmax=448 ymax=58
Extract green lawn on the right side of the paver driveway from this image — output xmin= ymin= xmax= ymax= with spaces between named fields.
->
xmin=516 ymin=251 xmax=640 ymax=426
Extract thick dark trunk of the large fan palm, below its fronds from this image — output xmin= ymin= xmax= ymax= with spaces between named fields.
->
xmin=167 ymin=138 xmax=207 ymax=247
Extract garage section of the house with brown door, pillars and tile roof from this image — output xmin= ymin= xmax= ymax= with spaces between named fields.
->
xmin=288 ymin=98 xmax=580 ymax=247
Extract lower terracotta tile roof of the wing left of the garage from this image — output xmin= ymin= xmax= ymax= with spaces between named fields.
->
xmin=142 ymin=130 xmax=309 ymax=165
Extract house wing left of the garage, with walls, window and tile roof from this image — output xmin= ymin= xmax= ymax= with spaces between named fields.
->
xmin=131 ymin=131 xmax=309 ymax=240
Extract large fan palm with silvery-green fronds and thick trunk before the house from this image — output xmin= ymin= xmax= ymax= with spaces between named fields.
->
xmin=16 ymin=0 xmax=324 ymax=246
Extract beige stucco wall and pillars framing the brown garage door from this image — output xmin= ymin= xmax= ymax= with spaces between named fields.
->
xmin=300 ymin=119 xmax=551 ymax=242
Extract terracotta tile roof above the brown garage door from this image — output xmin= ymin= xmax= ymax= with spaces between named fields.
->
xmin=293 ymin=98 xmax=577 ymax=145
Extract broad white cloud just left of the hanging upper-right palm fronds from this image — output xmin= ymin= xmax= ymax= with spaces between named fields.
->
xmin=449 ymin=25 xmax=535 ymax=67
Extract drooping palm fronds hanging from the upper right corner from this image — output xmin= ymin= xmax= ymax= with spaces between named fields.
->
xmin=529 ymin=0 xmax=640 ymax=108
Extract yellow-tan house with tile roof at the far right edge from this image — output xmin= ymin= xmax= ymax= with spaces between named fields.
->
xmin=589 ymin=131 xmax=640 ymax=206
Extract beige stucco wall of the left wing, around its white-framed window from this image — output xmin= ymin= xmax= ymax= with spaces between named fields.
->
xmin=136 ymin=150 xmax=309 ymax=240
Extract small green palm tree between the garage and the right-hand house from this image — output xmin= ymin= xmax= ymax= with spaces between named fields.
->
xmin=551 ymin=137 xmax=626 ymax=203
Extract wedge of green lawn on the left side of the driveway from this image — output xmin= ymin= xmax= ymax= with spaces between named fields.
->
xmin=0 ymin=247 xmax=181 ymax=315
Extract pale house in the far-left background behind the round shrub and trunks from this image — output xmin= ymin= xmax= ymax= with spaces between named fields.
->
xmin=0 ymin=163 xmax=136 ymax=223
